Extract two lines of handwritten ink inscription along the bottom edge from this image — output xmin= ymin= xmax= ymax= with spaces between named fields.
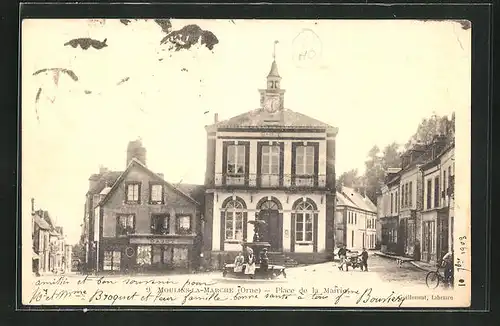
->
xmin=27 ymin=275 xmax=458 ymax=307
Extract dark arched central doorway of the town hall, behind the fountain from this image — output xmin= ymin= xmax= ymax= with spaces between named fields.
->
xmin=256 ymin=198 xmax=283 ymax=251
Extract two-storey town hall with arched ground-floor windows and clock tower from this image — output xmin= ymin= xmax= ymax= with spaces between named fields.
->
xmin=203 ymin=55 xmax=338 ymax=266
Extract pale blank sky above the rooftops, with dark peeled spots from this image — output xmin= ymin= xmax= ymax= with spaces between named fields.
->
xmin=21 ymin=20 xmax=471 ymax=243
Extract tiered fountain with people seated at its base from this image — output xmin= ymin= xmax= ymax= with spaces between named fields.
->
xmin=222 ymin=220 xmax=286 ymax=279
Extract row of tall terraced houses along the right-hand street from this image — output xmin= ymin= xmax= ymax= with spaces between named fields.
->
xmin=377 ymin=131 xmax=455 ymax=263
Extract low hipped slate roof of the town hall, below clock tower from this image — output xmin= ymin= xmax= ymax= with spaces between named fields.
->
xmin=209 ymin=108 xmax=336 ymax=129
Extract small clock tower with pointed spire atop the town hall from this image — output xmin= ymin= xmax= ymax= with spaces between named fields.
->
xmin=259 ymin=41 xmax=285 ymax=112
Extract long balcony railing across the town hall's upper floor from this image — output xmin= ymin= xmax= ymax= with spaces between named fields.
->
xmin=215 ymin=173 xmax=327 ymax=189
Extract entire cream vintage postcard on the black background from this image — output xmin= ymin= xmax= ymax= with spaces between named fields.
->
xmin=21 ymin=18 xmax=473 ymax=309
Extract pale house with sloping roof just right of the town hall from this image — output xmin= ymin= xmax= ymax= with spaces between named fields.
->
xmin=334 ymin=186 xmax=377 ymax=250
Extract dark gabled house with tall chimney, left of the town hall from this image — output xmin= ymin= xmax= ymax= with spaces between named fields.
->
xmin=87 ymin=141 xmax=203 ymax=273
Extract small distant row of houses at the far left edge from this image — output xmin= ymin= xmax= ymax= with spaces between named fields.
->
xmin=31 ymin=199 xmax=72 ymax=275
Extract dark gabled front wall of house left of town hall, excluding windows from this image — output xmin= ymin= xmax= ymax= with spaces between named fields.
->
xmin=95 ymin=166 xmax=201 ymax=272
